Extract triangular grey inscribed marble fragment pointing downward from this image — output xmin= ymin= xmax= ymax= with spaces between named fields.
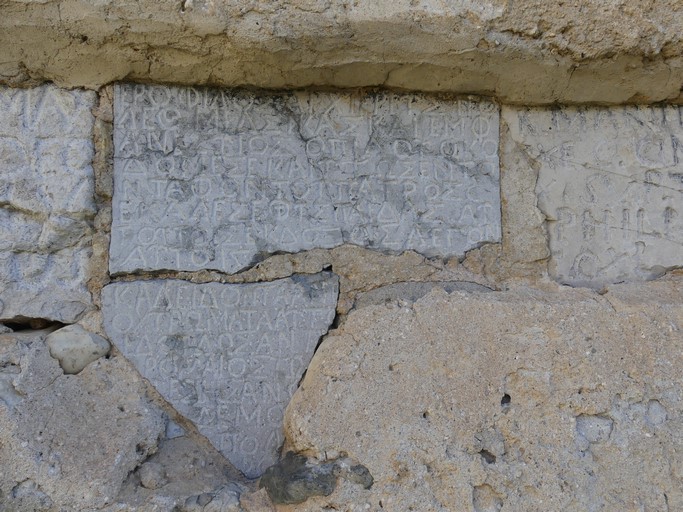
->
xmin=102 ymin=272 xmax=338 ymax=477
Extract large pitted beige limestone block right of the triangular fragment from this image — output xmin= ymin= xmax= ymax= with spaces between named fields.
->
xmin=281 ymin=278 xmax=683 ymax=512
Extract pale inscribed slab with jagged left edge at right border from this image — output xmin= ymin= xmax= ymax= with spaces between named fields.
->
xmin=503 ymin=106 xmax=683 ymax=286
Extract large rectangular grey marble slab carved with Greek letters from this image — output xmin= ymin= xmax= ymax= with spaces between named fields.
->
xmin=110 ymin=85 xmax=500 ymax=272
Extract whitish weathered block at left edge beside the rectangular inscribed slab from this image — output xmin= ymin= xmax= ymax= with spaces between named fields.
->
xmin=0 ymin=86 xmax=96 ymax=322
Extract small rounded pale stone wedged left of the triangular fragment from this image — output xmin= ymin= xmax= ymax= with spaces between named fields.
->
xmin=46 ymin=325 xmax=110 ymax=374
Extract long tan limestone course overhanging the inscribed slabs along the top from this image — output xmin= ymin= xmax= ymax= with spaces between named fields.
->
xmin=0 ymin=0 xmax=683 ymax=104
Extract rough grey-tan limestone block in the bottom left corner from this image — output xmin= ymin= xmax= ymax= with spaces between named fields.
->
xmin=0 ymin=331 xmax=164 ymax=511
